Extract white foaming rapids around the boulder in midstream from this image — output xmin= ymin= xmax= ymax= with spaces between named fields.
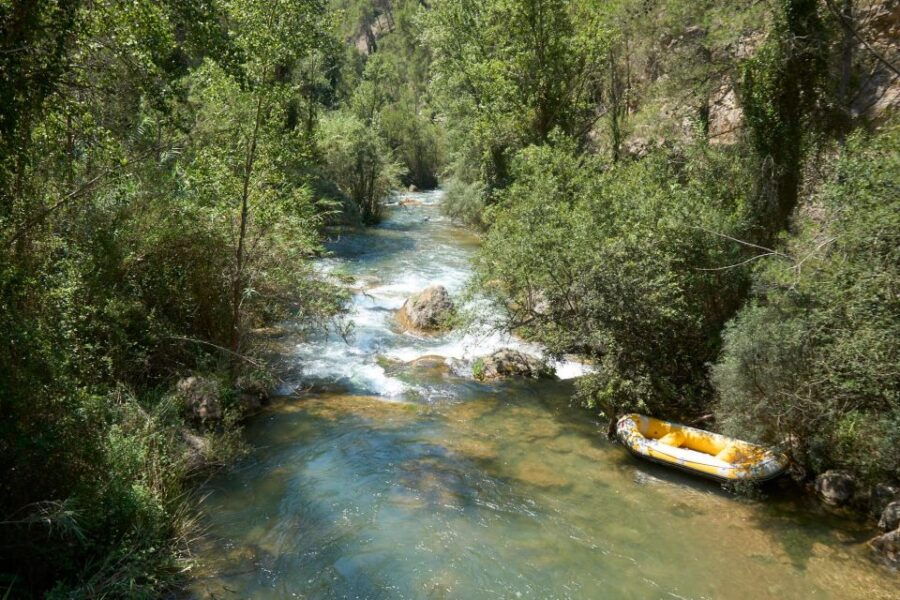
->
xmin=296 ymin=191 xmax=590 ymax=400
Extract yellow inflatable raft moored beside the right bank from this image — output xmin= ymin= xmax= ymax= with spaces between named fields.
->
xmin=616 ymin=414 xmax=787 ymax=481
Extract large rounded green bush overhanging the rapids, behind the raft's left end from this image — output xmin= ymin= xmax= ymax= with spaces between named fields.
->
xmin=476 ymin=140 xmax=746 ymax=418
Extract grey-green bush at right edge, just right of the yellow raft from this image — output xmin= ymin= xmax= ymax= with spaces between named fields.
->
xmin=713 ymin=125 xmax=900 ymax=481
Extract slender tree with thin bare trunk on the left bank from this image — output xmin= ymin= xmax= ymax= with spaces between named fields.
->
xmin=199 ymin=0 xmax=325 ymax=370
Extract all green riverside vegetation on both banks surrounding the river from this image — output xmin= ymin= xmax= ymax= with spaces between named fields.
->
xmin=0 ymin=0 xmax=900 ymax=598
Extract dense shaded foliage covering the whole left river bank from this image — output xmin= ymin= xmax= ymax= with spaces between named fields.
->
xmin=0 ymin=0 xmax=339 ymax=597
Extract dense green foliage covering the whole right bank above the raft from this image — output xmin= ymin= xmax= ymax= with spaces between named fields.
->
xmin=425 ymin=0 xmax=900 ymax=490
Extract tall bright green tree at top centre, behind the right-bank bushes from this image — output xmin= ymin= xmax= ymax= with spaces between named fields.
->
xmin=425 ymin=0 xmax=611 ymax=204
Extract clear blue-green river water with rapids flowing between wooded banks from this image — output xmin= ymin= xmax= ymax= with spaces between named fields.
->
xmin=191 ymin=192 xmax=900 ymax=600
